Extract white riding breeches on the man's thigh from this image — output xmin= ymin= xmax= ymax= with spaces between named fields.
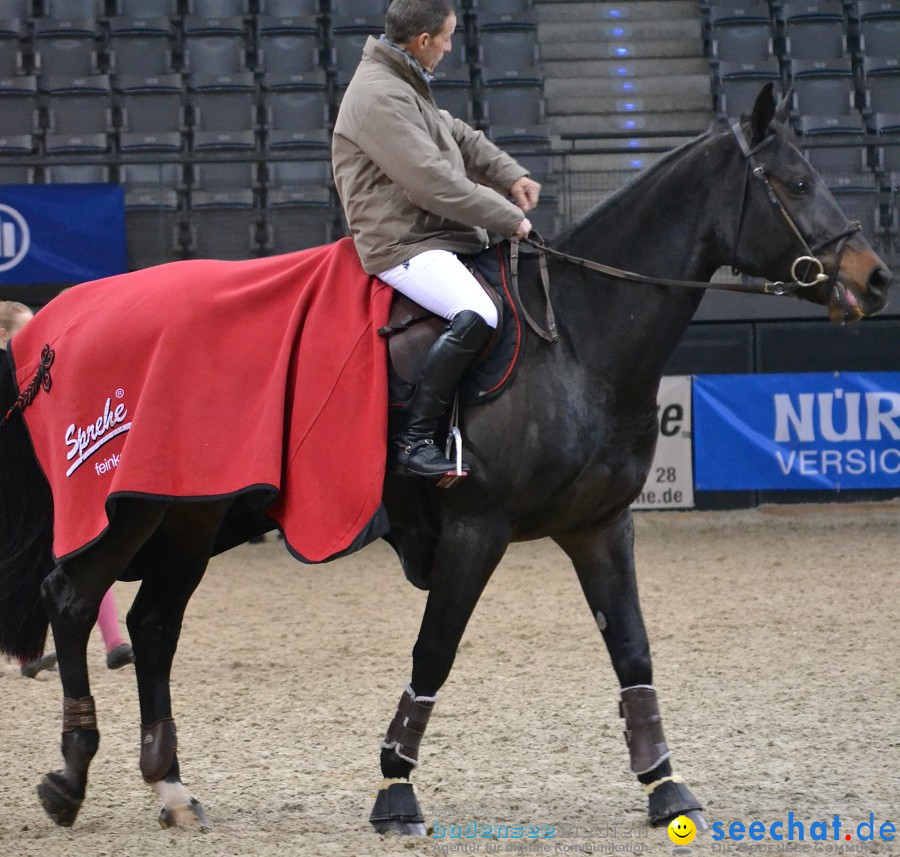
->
xmin=378 ymin=250 xmax=497 ymax=327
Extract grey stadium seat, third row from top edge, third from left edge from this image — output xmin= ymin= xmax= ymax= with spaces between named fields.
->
xmin=115 ymin=74 xmax=186 ymax=154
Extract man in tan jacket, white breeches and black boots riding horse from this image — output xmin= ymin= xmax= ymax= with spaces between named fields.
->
xmin=332 ymin=0 xmax=541 ymax=477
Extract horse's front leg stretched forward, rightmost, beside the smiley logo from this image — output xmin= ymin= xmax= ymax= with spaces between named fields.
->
xmin=555 ymin=509 xmax=708 ymax=830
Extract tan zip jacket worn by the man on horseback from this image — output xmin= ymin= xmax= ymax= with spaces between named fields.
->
xmin=332 ymin=37 xmax=528 ymax=274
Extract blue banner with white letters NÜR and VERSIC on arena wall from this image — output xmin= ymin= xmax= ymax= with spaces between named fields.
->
xmin=694 ymin=372 xmax=900 ymax=491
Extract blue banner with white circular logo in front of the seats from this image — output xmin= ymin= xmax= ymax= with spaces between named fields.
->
xmin=0 ymin=184 xmax=126 ymax=284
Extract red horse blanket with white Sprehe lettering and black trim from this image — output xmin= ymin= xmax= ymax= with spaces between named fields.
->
xmin=10 ymin=239 xmax=391 ymax=562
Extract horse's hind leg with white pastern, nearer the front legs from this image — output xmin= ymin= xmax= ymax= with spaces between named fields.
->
xmin=128 ymin=500 xmax=231 ymax=830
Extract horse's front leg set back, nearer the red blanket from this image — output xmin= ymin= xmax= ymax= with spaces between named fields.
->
xmin=369 ymin=516 xmax=510 ymax=836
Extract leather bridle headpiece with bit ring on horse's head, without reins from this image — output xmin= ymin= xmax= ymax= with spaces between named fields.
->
xmin=731 ymin=122 xmax=862 ymax=295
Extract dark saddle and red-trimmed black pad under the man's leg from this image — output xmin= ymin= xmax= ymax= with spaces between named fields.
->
xmin=378 ymin=242 xmax=523 ymax=410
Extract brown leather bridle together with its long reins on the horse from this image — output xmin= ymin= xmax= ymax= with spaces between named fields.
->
xmin=509 ymin=122 xmax=862 ymax=342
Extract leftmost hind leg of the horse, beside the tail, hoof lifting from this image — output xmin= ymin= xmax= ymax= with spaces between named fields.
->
xmin=38 ymin=502 xmax=164 ymax=827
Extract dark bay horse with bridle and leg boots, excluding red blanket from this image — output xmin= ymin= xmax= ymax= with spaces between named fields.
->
xmin=0 ymin=86 xmax=891 ymax=834
